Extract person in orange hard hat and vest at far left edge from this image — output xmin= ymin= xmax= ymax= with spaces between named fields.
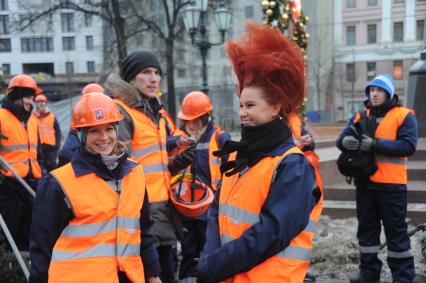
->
xmin=0 ymin=75 xmax=41 ymax=250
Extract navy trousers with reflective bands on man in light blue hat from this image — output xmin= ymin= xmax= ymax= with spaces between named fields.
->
xmin=356 ymin=186 xmax=415 ymax=282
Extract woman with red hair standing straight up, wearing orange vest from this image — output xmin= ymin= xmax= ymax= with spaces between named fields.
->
xmin=196 ymin=24 xmax=319 ymax=283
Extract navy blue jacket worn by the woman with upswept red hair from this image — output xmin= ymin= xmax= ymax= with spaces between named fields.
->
xmin=198 ymin=137 xmax=316 ymax=282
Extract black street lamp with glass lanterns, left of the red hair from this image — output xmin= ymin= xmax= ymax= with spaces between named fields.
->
xmin=183 ymin=0 xmax=231 ymax=93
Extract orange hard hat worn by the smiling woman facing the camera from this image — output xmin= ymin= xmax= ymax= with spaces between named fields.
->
xmin=71 ymin=92 xmax=124 ymax=128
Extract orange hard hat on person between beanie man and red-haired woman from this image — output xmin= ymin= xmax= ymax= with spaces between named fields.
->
xmin=178 ymin=91 xmax=213 ymax=120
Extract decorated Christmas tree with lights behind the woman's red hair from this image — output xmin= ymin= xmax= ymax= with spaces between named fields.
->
xmin=262 ymin=0 xmax=309 ymax=119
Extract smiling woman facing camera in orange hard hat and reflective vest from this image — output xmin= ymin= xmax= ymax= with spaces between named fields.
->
xmin=30 ymin=93 xmax=161 ymax=283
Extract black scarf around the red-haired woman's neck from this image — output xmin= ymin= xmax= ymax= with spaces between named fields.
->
xmin=213 ymin=118 xmax=291 ymax=177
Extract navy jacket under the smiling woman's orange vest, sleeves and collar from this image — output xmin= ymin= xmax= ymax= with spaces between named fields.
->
xmin=30 ymin=149 xmax=160 ymax=282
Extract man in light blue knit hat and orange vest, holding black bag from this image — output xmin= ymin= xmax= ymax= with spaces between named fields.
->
xmin=336 ymin=74 xmax=417 ymax=283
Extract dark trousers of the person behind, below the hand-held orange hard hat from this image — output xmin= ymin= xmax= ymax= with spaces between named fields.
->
xmin=179 ymin=219 xmax=207 ymax=279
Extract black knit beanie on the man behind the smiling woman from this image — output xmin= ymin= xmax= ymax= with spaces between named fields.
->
xmin=120 ymin=51 xmax=161 ymax=82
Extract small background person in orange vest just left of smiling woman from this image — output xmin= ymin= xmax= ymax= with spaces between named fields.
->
xmin=33 ymin=94 xmax=61 ymax=173
